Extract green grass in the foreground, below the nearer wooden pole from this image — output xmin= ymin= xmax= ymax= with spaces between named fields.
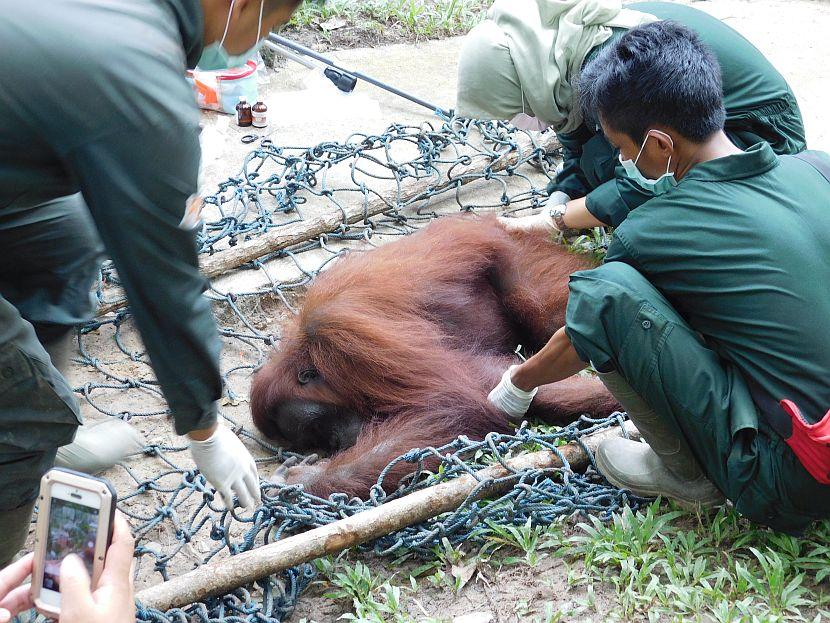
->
xmin=310 ymin=502 xmax=830 ymax=623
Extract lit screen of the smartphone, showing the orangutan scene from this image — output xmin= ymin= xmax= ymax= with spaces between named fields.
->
xmin=43 ymin=498 xmax=98 ymax=592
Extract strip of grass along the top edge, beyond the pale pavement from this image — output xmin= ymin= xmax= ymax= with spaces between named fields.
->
xmin=288 ymin=0 xmax=492 ymax=38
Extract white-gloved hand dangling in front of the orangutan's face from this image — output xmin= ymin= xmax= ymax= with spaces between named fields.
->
xmin=190 ymin=422 xmax=262 ymax=509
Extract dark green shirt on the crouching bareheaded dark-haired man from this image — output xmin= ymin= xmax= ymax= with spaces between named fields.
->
xmin=606 ymin=143 xmax=830 ymax=421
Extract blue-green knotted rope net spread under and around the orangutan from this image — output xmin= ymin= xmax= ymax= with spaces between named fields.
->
xmin=66 ymin=119 xmax=638 ymax=623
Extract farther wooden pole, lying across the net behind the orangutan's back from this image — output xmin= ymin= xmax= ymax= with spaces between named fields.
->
xmin=98 ymin=132 xmax=560 ymax=316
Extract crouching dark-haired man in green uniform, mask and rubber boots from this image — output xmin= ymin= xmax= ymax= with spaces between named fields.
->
xmin=490 ymin=22 xmax=830 ymax=534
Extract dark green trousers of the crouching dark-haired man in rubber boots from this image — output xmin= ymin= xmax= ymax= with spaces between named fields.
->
xmin=565 ymin=262 xmax=830 ymax=534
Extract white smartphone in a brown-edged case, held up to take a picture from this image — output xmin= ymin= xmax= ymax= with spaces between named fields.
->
xmin=32 ymin=468 xmax=116 ymax=617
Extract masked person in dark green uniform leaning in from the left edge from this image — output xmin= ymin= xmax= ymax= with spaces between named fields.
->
xmin=0 ymin=0 xmax=299 ymax=567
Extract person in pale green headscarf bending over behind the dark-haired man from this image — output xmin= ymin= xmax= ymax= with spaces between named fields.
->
xmin=456 ymin=0 xmax=806 ymax=230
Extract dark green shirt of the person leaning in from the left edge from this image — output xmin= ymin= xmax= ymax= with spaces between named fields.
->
xmin=0 ymin=0 xmax=221 ymax=433
